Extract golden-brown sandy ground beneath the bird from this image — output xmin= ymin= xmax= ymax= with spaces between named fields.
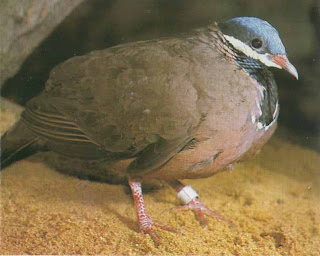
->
xmin=0 ymin=101 xmax=320 ymax=255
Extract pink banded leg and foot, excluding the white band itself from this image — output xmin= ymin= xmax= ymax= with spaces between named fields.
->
xmin=167 ymin=180 xmax=234 ymax=226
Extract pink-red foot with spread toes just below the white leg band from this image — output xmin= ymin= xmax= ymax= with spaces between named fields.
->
xmin=173 ymin=198 xmax=235 ymax=227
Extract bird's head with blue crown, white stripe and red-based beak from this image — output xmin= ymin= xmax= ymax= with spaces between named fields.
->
xmin=219 ymin=17 xmax=298 ymax=79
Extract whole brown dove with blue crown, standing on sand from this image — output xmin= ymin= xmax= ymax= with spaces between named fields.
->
xmin=1 ymin=17 xmax=298 ymax=243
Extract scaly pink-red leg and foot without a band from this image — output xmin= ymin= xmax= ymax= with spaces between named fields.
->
xmin=128 ymin=178 xmax=178 ymax=245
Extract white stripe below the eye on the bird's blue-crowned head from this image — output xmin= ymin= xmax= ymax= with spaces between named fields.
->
xmin=223 ymin=35 xmax=282 ymax=69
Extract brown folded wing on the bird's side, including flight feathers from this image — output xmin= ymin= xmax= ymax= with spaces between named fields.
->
xmin=24 ymin=39 xmax=208 ymax=173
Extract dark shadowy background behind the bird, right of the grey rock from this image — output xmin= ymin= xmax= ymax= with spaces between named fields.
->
xmin=1 ymin=0 xmax=320 ymax=150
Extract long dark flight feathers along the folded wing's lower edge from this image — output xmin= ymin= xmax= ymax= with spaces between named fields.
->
xmin=22 ymin=97 xmax=191 ymax=169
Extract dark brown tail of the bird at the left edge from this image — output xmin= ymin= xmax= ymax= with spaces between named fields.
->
xmin=0 ymin=121 xmax=42 ymax=170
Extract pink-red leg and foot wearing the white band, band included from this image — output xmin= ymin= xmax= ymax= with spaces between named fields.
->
xmin=167 ymin=180 xmax=234 ymax=226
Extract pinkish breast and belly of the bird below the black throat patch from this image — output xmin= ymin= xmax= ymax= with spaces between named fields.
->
xmin=142 ymin=71 xmax=279 ymax=179
